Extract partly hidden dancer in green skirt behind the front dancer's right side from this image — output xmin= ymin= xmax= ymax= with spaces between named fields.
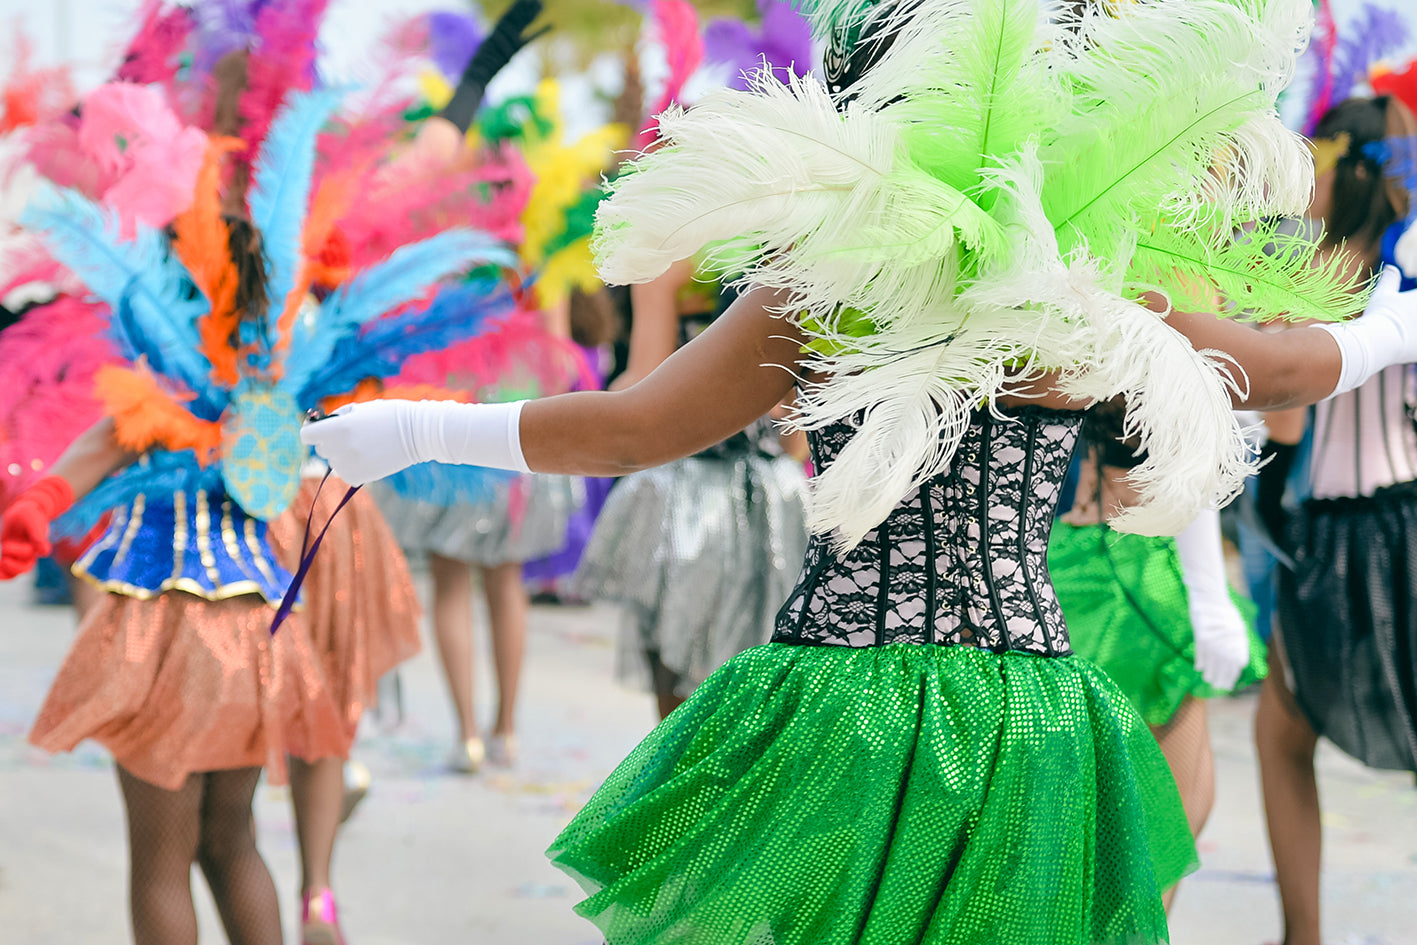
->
xmin=1049 ymin=404 xmax=1265 ymax=908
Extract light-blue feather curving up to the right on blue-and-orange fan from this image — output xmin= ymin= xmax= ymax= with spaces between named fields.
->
xmin=281 ymin=230 xmax=516 ymax=395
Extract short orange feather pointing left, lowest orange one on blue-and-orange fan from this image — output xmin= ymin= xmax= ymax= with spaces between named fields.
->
xmin=94 ymin=361 xmax=221 ymax=466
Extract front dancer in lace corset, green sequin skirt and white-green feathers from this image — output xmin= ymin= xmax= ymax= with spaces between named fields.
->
xmin=303 ymin=0 xmax=1417 ymax=945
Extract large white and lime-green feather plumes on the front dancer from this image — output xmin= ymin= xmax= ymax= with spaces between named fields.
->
xmin=595 ymin=0 xmax=1362 ymax=548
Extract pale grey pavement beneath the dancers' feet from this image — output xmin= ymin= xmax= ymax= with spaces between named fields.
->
xmin=0 ymin=582 xmax=1417 ymax=945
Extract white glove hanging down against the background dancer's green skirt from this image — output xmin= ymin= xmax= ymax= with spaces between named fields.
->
xmin=1176 ymin=509 xmax=1250 ymax=690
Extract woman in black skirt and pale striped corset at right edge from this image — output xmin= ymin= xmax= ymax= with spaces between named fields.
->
xmin=1255 ymin=96 xmax=1417 ymax=945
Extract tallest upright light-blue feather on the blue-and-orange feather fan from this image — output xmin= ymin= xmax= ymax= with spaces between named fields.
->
xmin=249 ymin=88 xmax=344 ymax=365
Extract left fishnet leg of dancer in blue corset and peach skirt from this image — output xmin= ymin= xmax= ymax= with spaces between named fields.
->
xmin=118 ymin=766 xmax=203 ymax=945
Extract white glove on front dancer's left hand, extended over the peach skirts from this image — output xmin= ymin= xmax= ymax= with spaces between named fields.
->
xmin=300 ymin=400 xmax=531 ymax=486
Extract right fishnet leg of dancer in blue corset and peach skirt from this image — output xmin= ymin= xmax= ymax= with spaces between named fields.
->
xmin=197 ymin=768 xmax=281 ymax=945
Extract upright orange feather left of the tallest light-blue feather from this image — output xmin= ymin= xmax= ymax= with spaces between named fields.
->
xmin=174 ymin=137 xmax=244 ymax=387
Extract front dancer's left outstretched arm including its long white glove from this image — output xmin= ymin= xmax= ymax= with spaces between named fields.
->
xmin=302 ymin=290 xmax=802 ymax=485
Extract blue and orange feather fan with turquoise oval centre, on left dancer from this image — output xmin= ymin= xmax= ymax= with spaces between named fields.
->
xmin=27 ymin=91 xmax=516 ymax=532
